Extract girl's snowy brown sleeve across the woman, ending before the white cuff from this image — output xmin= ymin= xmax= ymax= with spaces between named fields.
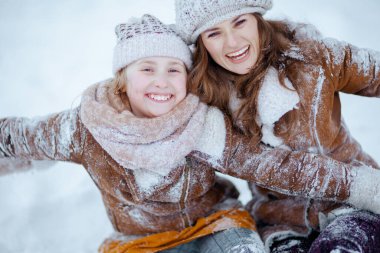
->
xmin=191 ymin=110 xmax=353 ymax=202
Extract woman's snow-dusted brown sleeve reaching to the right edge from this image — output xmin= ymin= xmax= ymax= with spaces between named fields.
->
xmin=321 ymin=38 xmax=380 ymax=97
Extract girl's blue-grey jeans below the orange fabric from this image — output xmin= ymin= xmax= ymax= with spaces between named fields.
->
xmin=162 ymin=228 xmax=265 ymax=253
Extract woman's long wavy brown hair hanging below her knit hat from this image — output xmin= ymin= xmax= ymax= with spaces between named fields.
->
xmin=189 ymin=13 xmax=297 ymax=142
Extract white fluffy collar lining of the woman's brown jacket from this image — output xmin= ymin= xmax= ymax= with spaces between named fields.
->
xmin=256 ymin=67 xmax=300 ymax=147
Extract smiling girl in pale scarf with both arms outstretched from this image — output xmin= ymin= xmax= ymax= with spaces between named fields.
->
xmin=0 ymin=12 xmax=380 ymax=252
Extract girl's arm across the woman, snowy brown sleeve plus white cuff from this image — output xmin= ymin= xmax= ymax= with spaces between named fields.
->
xmin=190 ymin=112 xmax=380 ymax=214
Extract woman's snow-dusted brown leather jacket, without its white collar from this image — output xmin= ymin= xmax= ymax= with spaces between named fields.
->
xmin=245 ymin=34 xmax=380 ymax=240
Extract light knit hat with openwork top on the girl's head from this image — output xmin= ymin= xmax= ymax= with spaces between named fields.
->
xmin=113 ymin=14 xmax=192 ymax=74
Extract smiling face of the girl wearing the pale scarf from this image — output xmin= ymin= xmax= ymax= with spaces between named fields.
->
xmin=126 ymin=57 xmax=187 ymax=118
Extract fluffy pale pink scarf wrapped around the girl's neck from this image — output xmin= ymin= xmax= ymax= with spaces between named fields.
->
xmin=80 ymin=81 xmax=207 ymax=175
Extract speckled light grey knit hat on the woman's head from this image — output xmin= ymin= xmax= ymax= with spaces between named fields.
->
xmin=175 ymin=0 xmax=272 ymax=44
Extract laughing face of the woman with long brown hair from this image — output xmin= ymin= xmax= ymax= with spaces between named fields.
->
xmin=201 ymin=14 xmax=260 ymax=75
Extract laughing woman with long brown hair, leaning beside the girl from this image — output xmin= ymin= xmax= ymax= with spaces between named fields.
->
xmin=176 ymin=0 xmax=380 ymax=252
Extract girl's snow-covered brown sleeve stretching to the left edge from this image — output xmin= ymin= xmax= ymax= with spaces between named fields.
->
xmin=0 ymin=108 xmax=82 ymax=169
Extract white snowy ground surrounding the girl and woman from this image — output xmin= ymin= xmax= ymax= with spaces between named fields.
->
xmin=0 ymin=0 xmax=380 ymax=253
